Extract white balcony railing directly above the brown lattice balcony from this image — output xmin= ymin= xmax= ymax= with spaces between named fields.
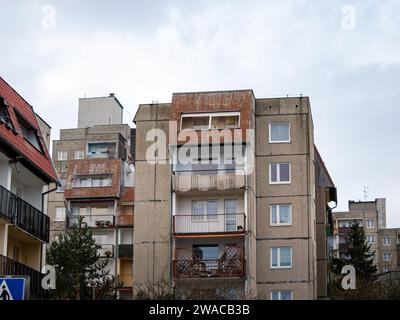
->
xmin=173 ymin=213 xmax=246 ymax=235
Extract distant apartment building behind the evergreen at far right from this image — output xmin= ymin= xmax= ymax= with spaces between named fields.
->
xmin=333 ymin=198 xmax=386 ymax=270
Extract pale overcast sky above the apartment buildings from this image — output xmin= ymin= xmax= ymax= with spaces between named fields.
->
xmin=0 ymin=0 xmax=400 ymax=227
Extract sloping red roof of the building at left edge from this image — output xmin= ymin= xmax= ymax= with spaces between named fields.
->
xmin=0 ymin=77 xmax=58 ymax=182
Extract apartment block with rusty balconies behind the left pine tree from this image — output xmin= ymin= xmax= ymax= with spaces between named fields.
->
xmin=48 ymin=94 xmax=135 ymax=299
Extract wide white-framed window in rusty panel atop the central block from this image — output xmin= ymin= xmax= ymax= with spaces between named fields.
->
xmin=181 ymin=112 xmax=240 ymax=130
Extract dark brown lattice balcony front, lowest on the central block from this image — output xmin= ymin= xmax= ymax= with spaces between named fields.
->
xmin=173 ymin=247 xmax=246 ymax=279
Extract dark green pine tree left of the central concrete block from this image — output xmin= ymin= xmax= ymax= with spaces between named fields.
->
xmin=47 ymin=217 xmax=115 ymax=300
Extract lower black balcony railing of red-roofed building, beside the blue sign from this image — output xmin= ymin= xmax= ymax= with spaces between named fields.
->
xmin=0 ymin=255 xmax=47 ymax=299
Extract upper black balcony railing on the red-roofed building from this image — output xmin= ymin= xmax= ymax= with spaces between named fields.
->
xmin=0 ymin=186 xmax=50 ymax=242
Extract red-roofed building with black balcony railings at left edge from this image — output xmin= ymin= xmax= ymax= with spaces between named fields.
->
xmin=0 ymin=78 xmax=58 ymax=298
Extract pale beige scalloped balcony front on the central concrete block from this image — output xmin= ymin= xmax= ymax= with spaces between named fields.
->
xmin=172 ymin=169 xmax=245 ymax=192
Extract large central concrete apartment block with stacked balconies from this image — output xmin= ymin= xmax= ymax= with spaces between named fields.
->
xmin=133 ymin=90 xmax=336 ymax=300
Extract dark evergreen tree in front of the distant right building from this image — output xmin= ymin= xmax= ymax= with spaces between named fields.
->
xmin=332 ymin=221 xmax=377 ymax=279
